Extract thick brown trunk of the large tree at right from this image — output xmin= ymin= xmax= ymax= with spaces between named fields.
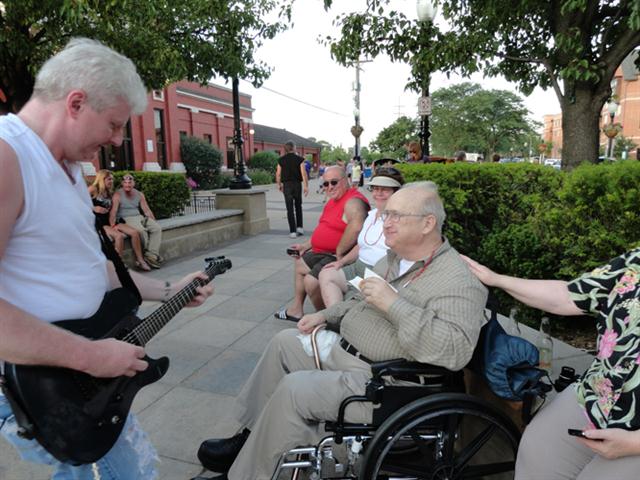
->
xmin=561 ymin=85 xmax=608 ymax=170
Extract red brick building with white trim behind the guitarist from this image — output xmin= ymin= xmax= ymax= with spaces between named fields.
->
xmin=91 ymin=80 xmax=321 ymax=175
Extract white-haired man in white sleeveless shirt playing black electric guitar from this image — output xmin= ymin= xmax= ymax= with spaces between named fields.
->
xmin=0 ymin=39 xmax=213 ymax=480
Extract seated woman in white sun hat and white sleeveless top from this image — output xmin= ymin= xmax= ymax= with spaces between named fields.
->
xmin=318 ymin=167 xmax=404 ymax=307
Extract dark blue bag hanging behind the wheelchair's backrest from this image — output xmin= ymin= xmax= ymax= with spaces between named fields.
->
xmin=469 ymin=315 xmax=545 ymax=401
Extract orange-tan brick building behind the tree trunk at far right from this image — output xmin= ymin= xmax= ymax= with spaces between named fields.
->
xmin=542 ymin=51 xmax=640 ymax=160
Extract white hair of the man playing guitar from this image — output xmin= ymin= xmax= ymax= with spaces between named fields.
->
xmin=33 ymin=37 xmax=147 ymax=114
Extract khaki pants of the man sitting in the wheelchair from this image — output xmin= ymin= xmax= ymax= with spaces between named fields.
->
xmin=229 ymin=329 xmax=373 ymax=480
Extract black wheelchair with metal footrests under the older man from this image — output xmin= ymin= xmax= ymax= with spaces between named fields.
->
xmin=271 ymin=306 xmax=564 ymax=480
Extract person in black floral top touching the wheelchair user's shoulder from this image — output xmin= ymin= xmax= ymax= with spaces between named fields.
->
xmin=465 ymin=249 xmax=640 ymax=480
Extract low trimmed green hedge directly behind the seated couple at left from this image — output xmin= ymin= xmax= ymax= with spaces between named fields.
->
xmin=113 ymin=171 xmax=191 ymax=218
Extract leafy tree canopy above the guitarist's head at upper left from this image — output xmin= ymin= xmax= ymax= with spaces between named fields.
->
xmin=0 ymin=0 xmax=293 ymax=113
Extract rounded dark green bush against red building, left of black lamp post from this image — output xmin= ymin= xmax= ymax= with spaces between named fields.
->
xmin=180 ymin=137 xmax=222 ymax=190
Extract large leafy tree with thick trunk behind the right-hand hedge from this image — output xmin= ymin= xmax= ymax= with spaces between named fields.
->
xmin=324 ymin=0 xmax=640 ymax=168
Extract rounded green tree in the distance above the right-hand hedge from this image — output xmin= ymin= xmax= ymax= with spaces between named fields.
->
xmin=431 ymin=83 xmax=534 ymax=158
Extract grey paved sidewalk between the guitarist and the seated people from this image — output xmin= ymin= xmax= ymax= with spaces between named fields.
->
xmin=0 ymin=185 xmax=588 ymax=480
